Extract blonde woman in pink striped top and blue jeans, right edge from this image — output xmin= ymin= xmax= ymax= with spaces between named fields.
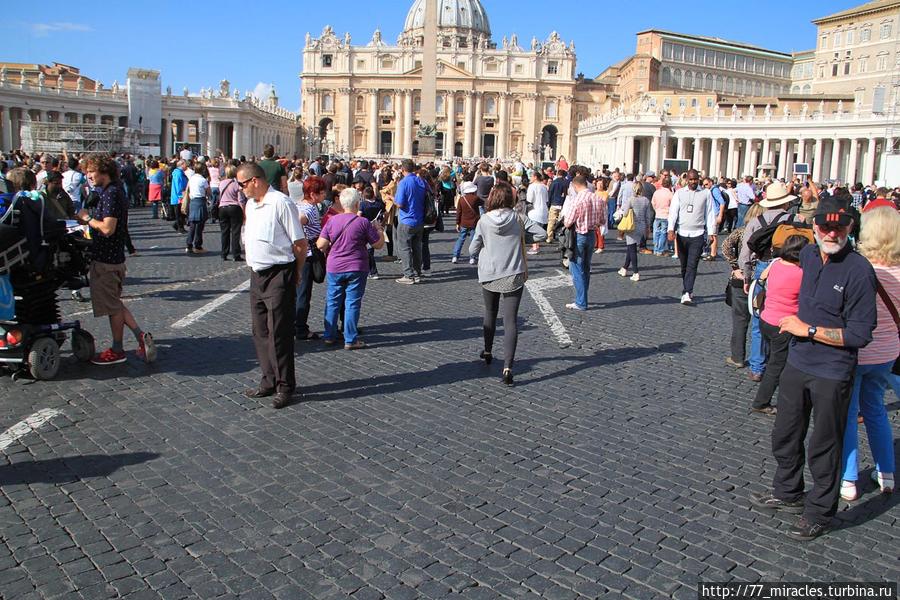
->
xmin=841 ymin=207 xmax=900 ymax=501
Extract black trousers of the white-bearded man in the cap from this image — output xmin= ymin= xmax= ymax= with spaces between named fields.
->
xmin=772 ymin=363 xmax=853 ymax=524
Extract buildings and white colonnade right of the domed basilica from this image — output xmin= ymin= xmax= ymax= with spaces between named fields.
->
xmin=576 ymin=0 xmax=900 ymax=183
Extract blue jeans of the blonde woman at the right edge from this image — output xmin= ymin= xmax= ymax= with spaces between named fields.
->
xmin=841 ymin=361 xmax=894 ymax=481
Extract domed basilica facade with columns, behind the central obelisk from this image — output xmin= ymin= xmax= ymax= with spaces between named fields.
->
xmin=301 ymin=0 xmax=576 ymax=160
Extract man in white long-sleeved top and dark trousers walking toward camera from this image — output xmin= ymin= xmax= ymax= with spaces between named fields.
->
xmin=667 ymin=169 xmax=716 ymax=304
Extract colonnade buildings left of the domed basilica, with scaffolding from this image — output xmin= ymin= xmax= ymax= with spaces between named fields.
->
xmin=0 ymin=63 xmax=299 ymax=156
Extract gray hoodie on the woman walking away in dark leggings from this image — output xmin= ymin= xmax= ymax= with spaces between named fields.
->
xmin=469 ymin=208 xmax=525 ymax=283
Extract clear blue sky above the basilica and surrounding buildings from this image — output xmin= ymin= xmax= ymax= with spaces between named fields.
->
xmin=0 ymin=0 xmax=862 ymax=110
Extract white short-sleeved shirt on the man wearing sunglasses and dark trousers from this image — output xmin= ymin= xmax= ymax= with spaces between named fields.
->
xmin=244 ymin=187 xmax=306 ymax=272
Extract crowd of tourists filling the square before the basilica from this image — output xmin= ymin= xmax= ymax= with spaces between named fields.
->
xmin=0 ymin=146 xmax=900 ymax=540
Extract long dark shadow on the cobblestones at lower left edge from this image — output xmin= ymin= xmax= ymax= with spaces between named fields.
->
xmin=0 ymin=452 xmax=160 ymax=486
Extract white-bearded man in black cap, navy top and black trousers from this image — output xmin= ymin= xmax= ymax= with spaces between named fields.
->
xmin=751 ymin=195 xmax=878 ymax=541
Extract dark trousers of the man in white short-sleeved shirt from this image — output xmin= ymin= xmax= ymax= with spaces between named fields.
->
xmin=250 ymin=262 xmax=297 ymax=392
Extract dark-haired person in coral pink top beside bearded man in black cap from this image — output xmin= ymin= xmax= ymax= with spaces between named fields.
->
xmin=750 ymin=235 xmax=809 ymax=416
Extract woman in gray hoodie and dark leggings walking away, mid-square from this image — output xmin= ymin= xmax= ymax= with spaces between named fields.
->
xmin=469 ymin=183 xmax=528 ymax=385
